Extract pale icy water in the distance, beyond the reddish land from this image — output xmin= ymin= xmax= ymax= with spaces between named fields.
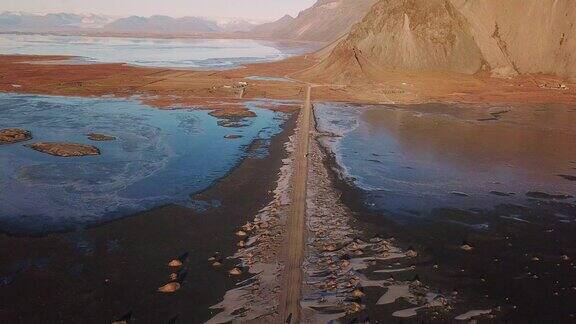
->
xmin=0 ymin=34 xmax=314 ymax=69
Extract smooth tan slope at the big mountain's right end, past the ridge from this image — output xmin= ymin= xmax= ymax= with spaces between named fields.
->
xmin=451 ymin=0 xmax=576 ymax=77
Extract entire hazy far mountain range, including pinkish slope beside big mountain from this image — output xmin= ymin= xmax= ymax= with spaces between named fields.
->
xmin=0 ymin=0 xmax=377 ymax=42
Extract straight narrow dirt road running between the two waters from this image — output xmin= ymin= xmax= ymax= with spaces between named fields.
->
xmin=278 ymin=85 xmax=312 ymax=323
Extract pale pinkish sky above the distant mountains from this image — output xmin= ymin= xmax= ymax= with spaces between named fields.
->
xmin=0 ymin=0 xmax=316 ymax=20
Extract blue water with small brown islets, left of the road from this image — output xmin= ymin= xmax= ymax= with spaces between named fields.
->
xmin=0 ymin=94 xmax=286 ymax=233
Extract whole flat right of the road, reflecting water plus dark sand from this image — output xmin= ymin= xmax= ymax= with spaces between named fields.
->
xmin=315 ymin=103 xmax=576 ymax=322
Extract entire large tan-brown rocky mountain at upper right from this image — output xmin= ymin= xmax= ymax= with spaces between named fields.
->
xmin=304 ymin=0 xmax=576 ymax=81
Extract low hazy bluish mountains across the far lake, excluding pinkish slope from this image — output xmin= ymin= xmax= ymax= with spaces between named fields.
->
xmin=0 ymin=12 xmax=256 ymax=36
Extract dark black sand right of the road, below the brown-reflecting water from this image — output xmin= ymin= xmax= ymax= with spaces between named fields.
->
xmin=325 ymin=130 xmax=576 ymax=323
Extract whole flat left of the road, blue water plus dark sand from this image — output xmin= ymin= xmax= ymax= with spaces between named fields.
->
xmin=0 ymin=94 xmax=295 ymax=323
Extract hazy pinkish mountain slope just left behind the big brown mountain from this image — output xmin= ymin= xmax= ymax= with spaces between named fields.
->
xmin=251 ymin=0 xmax=377 ymax=42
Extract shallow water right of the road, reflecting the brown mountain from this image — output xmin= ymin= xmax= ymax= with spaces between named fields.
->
xmin=315 ymin=103 xmax=576 ymax=221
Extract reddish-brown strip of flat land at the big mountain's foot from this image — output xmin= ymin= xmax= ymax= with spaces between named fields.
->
xmin=0 ymin=55 xmax=576 ymax=112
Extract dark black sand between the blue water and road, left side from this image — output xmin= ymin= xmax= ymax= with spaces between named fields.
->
xmin=0 ymin=116 xmax=295 ymax=323
